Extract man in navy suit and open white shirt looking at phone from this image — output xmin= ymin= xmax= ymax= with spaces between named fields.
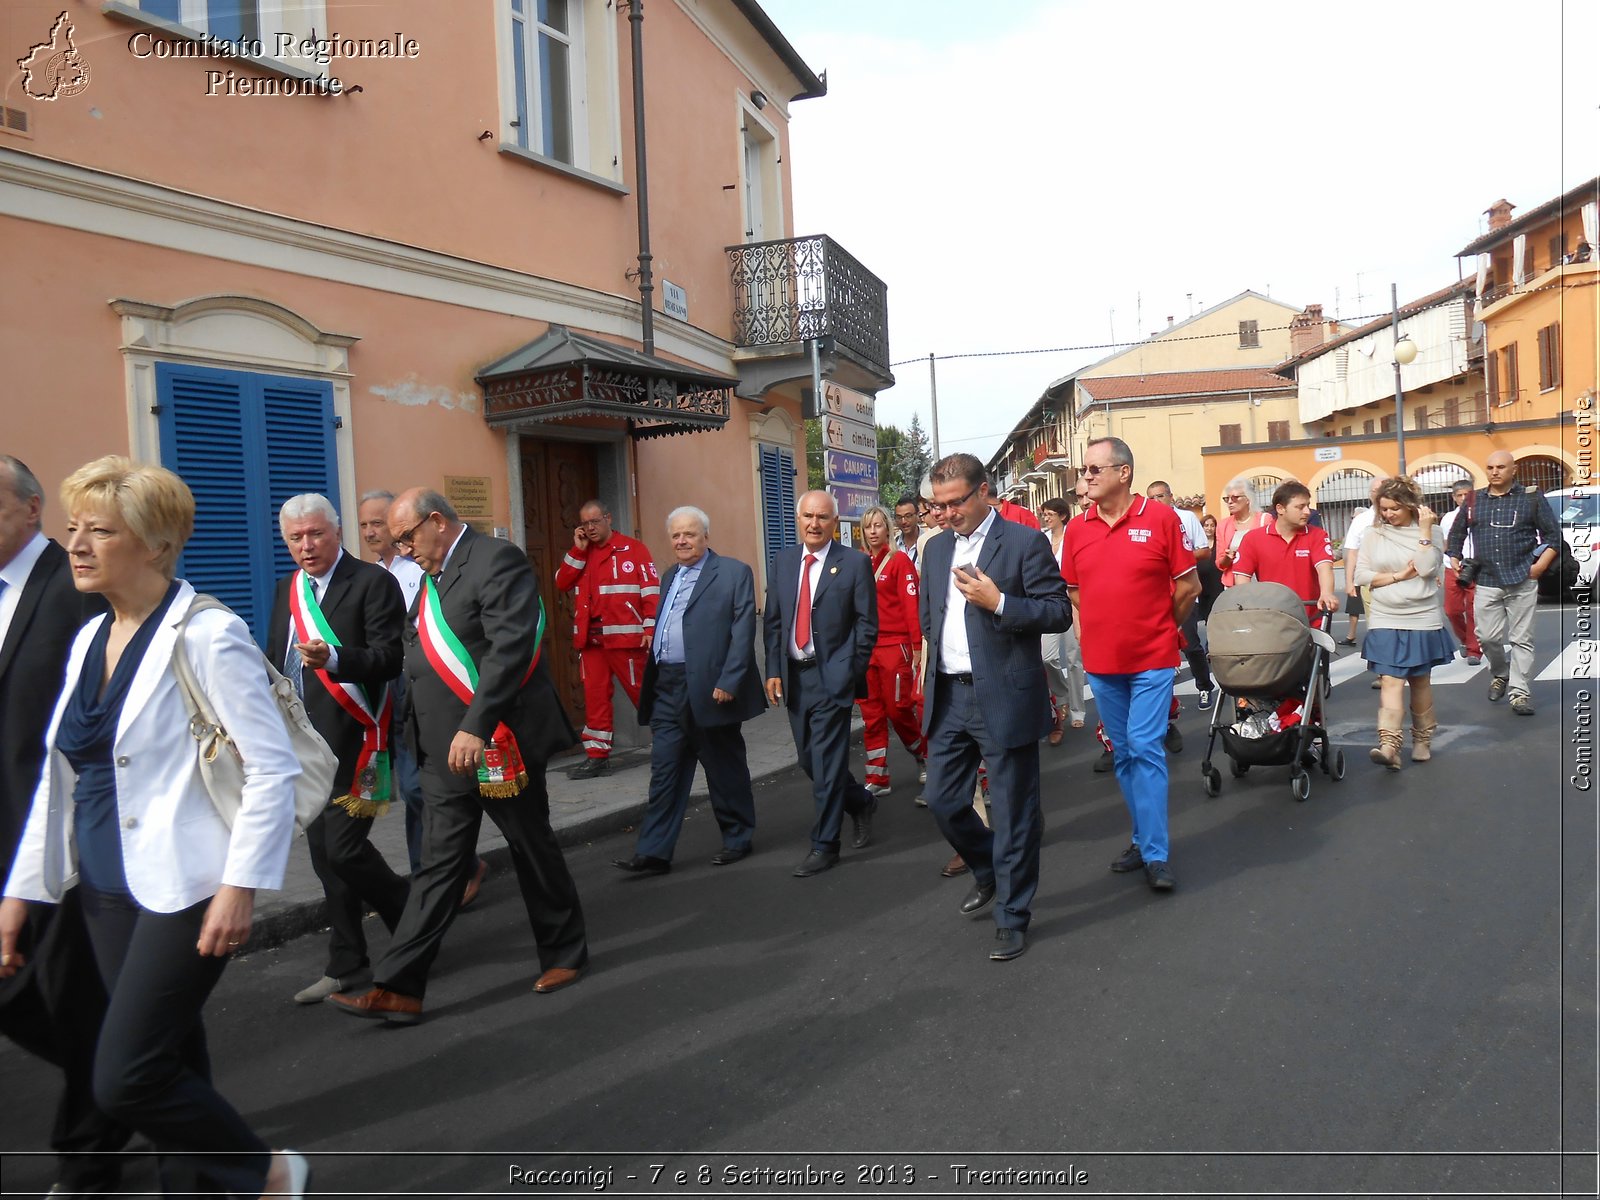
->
xmin=920 ymin=454 xmax=1072 ymax=962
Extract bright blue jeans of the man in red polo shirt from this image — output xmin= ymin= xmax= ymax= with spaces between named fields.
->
xmin=1090 ymin=667 xmax=1176 ymax=862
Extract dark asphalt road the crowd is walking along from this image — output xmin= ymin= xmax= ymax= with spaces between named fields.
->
xmin=0 ymin=610 xmax=1597 ymax=1197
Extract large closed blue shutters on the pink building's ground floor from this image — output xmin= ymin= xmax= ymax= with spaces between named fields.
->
xmin=155 ymin=363 xmax=339 ymax=645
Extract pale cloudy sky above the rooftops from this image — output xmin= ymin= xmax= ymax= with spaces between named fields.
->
xmin=762 ymin=0 xmax=1600 ymax=459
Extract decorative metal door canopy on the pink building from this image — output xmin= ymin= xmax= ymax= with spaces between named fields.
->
xmin=477 ymin=325 xmax=739 ymax=437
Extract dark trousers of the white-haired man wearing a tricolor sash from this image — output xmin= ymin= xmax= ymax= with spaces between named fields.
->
xmin=306 ymin=805 xmax=406 ymax=979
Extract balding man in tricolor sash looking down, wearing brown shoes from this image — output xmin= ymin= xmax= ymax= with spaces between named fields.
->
xmin=328 ymin=488 xmax=589 ymax=1024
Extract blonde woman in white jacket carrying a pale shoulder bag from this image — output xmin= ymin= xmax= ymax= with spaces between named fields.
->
xmin=0 ymin=456 xmax=310 ymax=1197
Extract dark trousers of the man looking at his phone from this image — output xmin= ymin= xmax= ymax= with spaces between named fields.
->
xmin=925 ymin=675 xmax=1045 ymax=930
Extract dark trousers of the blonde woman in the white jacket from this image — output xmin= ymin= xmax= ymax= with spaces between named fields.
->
xmin=77 ymin=886 xmax=270 ymax=1195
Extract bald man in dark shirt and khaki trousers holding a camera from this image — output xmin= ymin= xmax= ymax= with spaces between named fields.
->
xmin=1445 ymin=450 xmax=1562 ymax=717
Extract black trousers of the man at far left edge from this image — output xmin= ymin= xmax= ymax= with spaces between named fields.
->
xmin=0 ymin=888 xmax=130 ymax=1192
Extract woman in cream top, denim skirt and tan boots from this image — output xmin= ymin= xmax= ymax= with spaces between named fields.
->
xmin=1355 ymin=475 xmax=1456 ymax=771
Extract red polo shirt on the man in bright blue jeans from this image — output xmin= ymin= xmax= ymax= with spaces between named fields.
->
xmin=1061 ymin=496 xmax=1195 ymax=675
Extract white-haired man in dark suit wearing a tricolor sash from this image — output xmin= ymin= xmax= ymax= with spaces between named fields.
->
xmin=267 ymin=493 xmax=406 ymax=1005
